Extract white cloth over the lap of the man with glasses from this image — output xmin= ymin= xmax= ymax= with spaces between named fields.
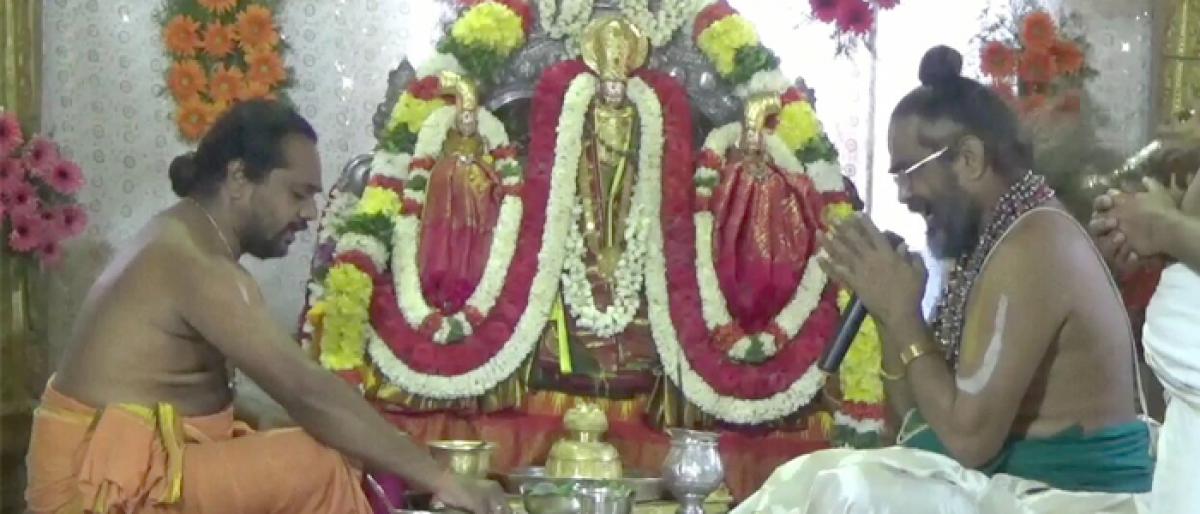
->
xmin=732 ymin=447 xmax=1150 ymax=514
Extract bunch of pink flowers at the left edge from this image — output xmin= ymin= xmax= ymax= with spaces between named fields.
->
xmin=0 ymin=112 xmax=88 ymax=267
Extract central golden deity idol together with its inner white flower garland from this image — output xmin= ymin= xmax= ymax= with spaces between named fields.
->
xmin=530 ymin=18 xmax=691 ymax=398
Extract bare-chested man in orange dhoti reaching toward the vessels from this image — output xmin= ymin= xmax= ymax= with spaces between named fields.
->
xmin=26 ymin=101 xmax=504 ymax=514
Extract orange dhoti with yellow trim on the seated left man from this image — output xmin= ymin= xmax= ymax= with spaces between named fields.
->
xmin=25 ymin=384 xmax=371 ymax=514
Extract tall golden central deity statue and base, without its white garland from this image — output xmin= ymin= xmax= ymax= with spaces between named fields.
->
xmin=536 ymin=18 xmax=661 ymax=398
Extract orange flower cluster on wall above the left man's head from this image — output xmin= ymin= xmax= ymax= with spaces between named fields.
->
xmin=158 ymin=0 xmax=292 ymax=142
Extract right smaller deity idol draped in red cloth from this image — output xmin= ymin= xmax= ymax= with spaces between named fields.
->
xmin=710 ymin=95 xmax=823 ymax=333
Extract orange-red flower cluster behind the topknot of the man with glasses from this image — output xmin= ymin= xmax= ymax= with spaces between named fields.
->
xmin=977 ymin=4 xmax=1096 ymax=114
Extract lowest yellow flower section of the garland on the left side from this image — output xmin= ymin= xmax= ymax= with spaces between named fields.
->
xmin=310 ymin=263 xmax=372 ymax=371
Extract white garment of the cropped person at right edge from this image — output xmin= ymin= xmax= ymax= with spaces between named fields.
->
xmin=1142 ymin=264 xmax=1200 ymax=514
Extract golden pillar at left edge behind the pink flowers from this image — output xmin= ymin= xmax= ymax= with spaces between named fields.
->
xmin=0 ymin=0 xmax=46 ymax=513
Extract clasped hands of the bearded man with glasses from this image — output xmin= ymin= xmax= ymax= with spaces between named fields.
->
xmin=817 ymin=213 xmax=929 ymax=328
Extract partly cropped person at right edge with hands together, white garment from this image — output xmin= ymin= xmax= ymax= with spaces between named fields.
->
xmin=1091 ymin=122 xmax=1200 ymax=514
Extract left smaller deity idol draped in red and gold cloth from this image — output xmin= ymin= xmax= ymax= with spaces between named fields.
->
xmin=418 ymin=72 xmax=504 ymax=313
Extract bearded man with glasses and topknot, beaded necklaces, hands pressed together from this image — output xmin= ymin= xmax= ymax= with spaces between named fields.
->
xmin=737 ymin=47 xmax=1153 ymax=513
